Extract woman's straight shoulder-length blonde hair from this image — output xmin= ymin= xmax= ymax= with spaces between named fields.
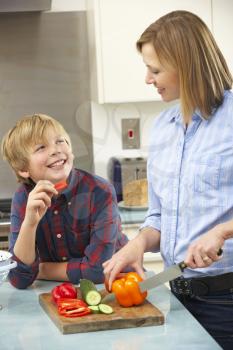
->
xmin=136 ymin=11 xmax=232 ymax=118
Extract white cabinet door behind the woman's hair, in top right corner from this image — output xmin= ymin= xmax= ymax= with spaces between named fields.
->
xmin=212 ymin=0 xmax=233 ymax=74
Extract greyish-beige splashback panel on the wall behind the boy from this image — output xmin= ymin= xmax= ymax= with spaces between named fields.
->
xmin=0 ymin=11 xmax=93 ymax=199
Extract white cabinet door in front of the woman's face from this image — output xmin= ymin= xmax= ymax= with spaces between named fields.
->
xmin=87 ymin=0 xmax=212 ymax=103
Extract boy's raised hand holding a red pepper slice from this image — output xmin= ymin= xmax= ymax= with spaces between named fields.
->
xmin=24 ymin=180 xmax=58 ymax=226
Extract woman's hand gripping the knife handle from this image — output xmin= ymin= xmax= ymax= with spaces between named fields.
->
xmin=184 ymin=225 xmax=224 ymax=269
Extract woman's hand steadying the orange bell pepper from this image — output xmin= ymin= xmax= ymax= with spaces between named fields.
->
xmin=103 ymin=236 xmax=145 ymax=290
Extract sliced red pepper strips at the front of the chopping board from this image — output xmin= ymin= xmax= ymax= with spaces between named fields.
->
xmin=57 ymin=298 xmax=91 ymax=317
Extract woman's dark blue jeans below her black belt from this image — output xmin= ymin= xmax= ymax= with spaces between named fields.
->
xmin=173 ymin=290 xmax=233 ymax=350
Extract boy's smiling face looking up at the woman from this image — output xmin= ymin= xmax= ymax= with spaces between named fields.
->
xmin=19 ymin=128 xmax=74 ymax=184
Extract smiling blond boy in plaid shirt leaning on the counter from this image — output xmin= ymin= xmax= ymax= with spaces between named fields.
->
xmin=2 ymin=114 xmax=128 ymax=288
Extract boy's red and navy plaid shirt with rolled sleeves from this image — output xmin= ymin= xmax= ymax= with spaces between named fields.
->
xmin=9 ymin=169 xmax=128 ymax=288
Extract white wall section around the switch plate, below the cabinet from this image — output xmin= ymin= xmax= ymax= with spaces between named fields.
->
xmin=92 ymin=102 xmax=175 ymax=178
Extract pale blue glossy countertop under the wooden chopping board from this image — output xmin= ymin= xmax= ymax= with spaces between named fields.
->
xmin=0 ymin=281 xmax=221 ymax=350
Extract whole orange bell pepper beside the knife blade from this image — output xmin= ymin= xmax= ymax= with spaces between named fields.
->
xmin=112 ymin=272 xmax=147 ymax=307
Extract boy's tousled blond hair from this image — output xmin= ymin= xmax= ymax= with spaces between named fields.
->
xmin=1 ymin=114 xmax=71 ymax=183
